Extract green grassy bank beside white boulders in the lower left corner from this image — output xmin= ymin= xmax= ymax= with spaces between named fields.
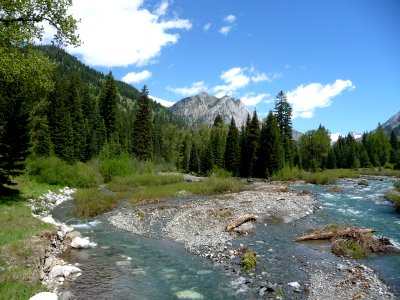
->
xmin=0 ymin=176 xmax=60 ymax=299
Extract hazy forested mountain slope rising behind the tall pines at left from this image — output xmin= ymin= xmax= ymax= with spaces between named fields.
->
xmin=36 ymin=45 xmax=183 ymax=125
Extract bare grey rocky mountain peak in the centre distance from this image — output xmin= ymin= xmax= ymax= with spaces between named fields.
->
xmin=171 ymin=93 xmax=250 ymax=127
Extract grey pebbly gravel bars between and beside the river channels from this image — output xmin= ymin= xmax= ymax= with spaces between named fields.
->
xmin=108 ymin=182 xmax=397 ymax=299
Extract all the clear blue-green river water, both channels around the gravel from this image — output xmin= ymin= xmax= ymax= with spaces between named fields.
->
xmin=54 ymin=180 xmax=400 ymax=299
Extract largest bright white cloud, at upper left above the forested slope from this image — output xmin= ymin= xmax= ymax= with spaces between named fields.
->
xmin=63 ymin=0 xmax=192 ymax=67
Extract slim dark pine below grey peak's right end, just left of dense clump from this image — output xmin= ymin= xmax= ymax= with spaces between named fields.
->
xmin=224 ymin=117 xmax=240 ymax=175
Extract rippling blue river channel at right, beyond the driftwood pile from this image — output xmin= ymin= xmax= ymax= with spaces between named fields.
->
xmin=293 ymin=179 xmax=400 ymax=294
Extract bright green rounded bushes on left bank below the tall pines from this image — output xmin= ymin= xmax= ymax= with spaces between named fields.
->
xmin=26 ymin=157 xmax=101 ymax=188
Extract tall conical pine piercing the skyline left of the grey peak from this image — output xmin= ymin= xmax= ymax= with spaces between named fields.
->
xmin=132 ymin=86 xmax=153 ymax=160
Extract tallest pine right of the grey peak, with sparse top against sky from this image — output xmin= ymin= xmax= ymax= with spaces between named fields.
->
xmin=275 ymin=91 xmax=294 ymax=166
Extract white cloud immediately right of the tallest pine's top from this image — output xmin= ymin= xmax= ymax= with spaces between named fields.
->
xmin=287 ymin=79 xmax=354 ymax=119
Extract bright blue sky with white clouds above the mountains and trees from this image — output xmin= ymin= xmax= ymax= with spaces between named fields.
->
xmin=54 ymin=0 xmax=400 ymax=134
